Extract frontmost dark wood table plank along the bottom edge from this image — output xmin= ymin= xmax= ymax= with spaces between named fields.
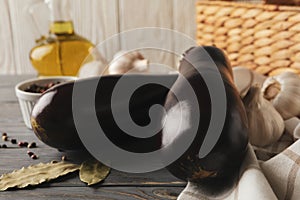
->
xmin=1 ymin=187 xmax=183 ymax=200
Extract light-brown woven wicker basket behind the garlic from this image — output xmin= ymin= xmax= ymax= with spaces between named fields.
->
xmin=197 ymin=1 xmax=300 ymax=76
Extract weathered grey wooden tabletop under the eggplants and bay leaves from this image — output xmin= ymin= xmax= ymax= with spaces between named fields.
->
xmin=0 ymin=75 xmax=186 ymax=200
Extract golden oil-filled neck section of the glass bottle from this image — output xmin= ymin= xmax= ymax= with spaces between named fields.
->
xmin=50 ymin=21 xmax=74 ymax=35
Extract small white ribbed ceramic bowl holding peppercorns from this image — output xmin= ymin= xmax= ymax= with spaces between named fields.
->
xmin=15 ymin=76 xmax=77 ymax=129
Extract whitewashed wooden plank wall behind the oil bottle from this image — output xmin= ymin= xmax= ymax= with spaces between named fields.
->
xmin=0 ymin=0 xmax=196 ymax=74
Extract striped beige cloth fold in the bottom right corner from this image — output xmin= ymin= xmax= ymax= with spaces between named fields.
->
xmin=261 ymin=140 xmax=300 ymax=200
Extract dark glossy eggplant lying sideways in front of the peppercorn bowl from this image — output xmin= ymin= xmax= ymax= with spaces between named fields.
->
xmin=31 ymin=74 xmax=178 ymax=152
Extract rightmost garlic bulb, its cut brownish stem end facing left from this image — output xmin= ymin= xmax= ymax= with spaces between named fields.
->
xmin=262 ymin=72 xmax=300 ymax=119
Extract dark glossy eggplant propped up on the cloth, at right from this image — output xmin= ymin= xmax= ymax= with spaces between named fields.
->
xmin=162 ymin=46 xmax=248 ymax=183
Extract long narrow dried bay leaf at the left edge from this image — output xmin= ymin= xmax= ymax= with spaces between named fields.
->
xmin=0 ymin=161 xmax=80 ymax=191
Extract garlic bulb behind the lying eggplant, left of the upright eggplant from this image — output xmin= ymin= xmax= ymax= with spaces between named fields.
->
xmin=108 ymin=51 xmax=149 ymax=74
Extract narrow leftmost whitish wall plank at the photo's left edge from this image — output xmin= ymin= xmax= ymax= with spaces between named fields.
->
xmin=0 ymin=0 xmax=16 ymax=74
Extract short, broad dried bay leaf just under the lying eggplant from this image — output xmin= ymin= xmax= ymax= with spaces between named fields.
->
xmin=79 ymin=159 xmax=110 ymax=185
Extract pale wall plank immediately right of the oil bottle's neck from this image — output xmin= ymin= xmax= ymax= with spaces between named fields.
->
xmin=72 ymin=0 xmax=120 ymax=60
